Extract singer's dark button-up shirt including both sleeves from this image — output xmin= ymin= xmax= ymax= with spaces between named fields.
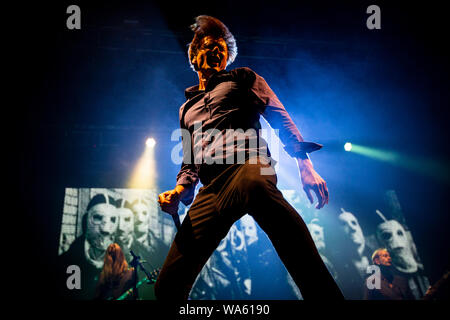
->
xmin=177 ymin=68 xmax=321 ymax=205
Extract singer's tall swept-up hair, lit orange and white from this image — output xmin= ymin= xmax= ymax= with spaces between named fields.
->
xmin=188 ymin=15 xmax=237 ymax=71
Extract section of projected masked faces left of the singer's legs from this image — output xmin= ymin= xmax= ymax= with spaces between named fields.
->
xmin=58 ymin=188 xmax=175 ymax=299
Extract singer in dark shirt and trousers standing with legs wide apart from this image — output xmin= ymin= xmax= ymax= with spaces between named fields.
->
xmin=155 ymin=16 xmax=343 ymax=300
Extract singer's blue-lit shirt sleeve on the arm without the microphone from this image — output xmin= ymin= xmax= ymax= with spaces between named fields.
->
xmin=246 ymin=71 xmax=322 ymax=158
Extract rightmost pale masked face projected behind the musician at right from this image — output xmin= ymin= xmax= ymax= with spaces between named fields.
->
xmin=376 ymin=220 xmax=418 ymax=273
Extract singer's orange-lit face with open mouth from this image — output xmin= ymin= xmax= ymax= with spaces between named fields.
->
xmin=193 ymin=36 xmax=228 ymax=72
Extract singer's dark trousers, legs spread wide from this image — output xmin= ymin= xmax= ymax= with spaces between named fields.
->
xmin=155 ymin=162 xmax=343 ymax=300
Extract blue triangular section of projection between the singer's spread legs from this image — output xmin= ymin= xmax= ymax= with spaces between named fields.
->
xmin=190 ymin=215 xmax=301 ymax=300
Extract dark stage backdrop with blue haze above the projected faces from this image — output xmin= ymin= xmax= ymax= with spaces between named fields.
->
xmin=16 ymin=1 xmax=450 ymax=297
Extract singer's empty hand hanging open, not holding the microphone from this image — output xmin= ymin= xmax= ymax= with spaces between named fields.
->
xmin=297 ymin=159 xmax=328 ymax=209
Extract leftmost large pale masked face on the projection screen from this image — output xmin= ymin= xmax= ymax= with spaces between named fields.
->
xmin=86 ymin=203 xmax=119 ymax=250
